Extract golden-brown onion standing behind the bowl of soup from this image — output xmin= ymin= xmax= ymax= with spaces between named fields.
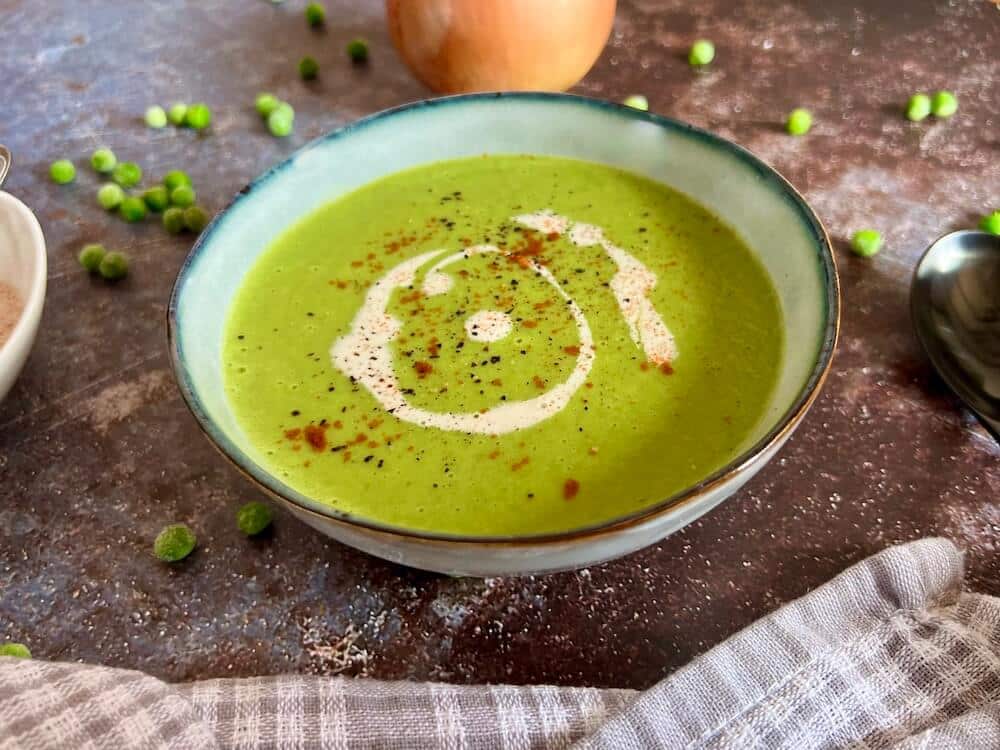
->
xmin=385 ymin=0 xmax=616 ymax=94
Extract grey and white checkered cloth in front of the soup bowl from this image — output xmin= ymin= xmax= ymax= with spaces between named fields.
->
xmin=0 ymin=539 xmax=1000 ymax=750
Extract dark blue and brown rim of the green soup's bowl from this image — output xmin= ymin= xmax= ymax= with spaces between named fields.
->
xmin=167 ymin=91 xmax=840 ymax=545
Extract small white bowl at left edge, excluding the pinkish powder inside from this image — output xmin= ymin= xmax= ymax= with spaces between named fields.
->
xmin=0 ymin=192 xmax=47 ymax=401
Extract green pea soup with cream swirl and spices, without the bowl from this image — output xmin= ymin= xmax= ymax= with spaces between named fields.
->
xmin=223 ymin=155 xmax=784 ymax=536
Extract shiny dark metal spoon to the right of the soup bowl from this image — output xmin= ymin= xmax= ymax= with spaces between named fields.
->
xmin=910 ymin=231 xmax=1000 ymax=442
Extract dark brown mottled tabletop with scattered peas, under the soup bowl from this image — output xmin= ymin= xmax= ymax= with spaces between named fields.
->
xmin=0 ymin=0 xmax=1000 ymax=687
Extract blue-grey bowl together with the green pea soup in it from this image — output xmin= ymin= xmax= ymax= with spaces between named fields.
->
xmin=169 ymin=93 xmax=839 ymax=575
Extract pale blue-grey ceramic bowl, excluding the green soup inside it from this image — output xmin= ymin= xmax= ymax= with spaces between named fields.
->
xmin=169 ymin=93 xmax=839 ymax=576
